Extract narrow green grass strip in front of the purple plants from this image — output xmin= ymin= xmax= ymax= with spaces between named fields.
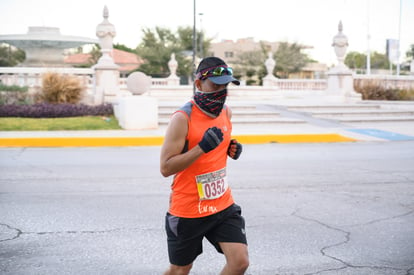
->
xmin=0 ymin=116 xmax=122 ymax=131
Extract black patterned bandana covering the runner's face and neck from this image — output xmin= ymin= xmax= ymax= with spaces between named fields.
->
xmin=194 ymin=88 xmax=227 ymax=117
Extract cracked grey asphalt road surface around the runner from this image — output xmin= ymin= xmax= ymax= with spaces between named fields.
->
xmin=0 ymin=141 xmax=414 ymax=275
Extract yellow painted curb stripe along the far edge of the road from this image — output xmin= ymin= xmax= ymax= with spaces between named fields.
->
xmin=0 ymin=134 xmax=357 ymax=147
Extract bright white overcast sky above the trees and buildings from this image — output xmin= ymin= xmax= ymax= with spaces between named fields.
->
xmin=0 ymin=0 xmax=414 ymax=65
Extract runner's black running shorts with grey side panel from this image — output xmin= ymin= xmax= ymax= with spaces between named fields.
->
xmin=165 ymin=204 xmax=247 ymax=266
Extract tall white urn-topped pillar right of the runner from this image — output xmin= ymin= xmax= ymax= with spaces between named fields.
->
xmin=327 ymin=21 xmax=362 ymax=102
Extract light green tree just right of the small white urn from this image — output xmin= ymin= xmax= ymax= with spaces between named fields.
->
xmin=273 ymin=42 xmax=309 ymax=78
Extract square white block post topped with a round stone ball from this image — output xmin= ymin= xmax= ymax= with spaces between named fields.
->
xmin=115 ymin=72 xmax=158 ymax=130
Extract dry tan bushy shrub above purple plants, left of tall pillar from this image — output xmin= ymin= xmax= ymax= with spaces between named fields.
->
xmin=40 ymin=72 xmax=85 ymax=104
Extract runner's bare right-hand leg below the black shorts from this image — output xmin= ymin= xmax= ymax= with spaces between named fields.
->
xmin=219 ymin=242 xmax=249 ymax=275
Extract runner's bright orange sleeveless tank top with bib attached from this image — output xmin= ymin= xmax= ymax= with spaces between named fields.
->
xmin=169 ymin=101 xmax=234 ymax=218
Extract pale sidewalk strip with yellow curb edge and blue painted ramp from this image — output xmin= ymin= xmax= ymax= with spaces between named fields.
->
xmin=0 ymin=122 xmax=414 ymax=147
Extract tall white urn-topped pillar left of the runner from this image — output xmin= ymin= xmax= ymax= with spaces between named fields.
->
xmin=93 ymin=6 xmax=120 ymax=104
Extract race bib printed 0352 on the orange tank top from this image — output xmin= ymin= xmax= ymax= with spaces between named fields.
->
xmin=196 ymin=168 xmax=228 ymax=200
